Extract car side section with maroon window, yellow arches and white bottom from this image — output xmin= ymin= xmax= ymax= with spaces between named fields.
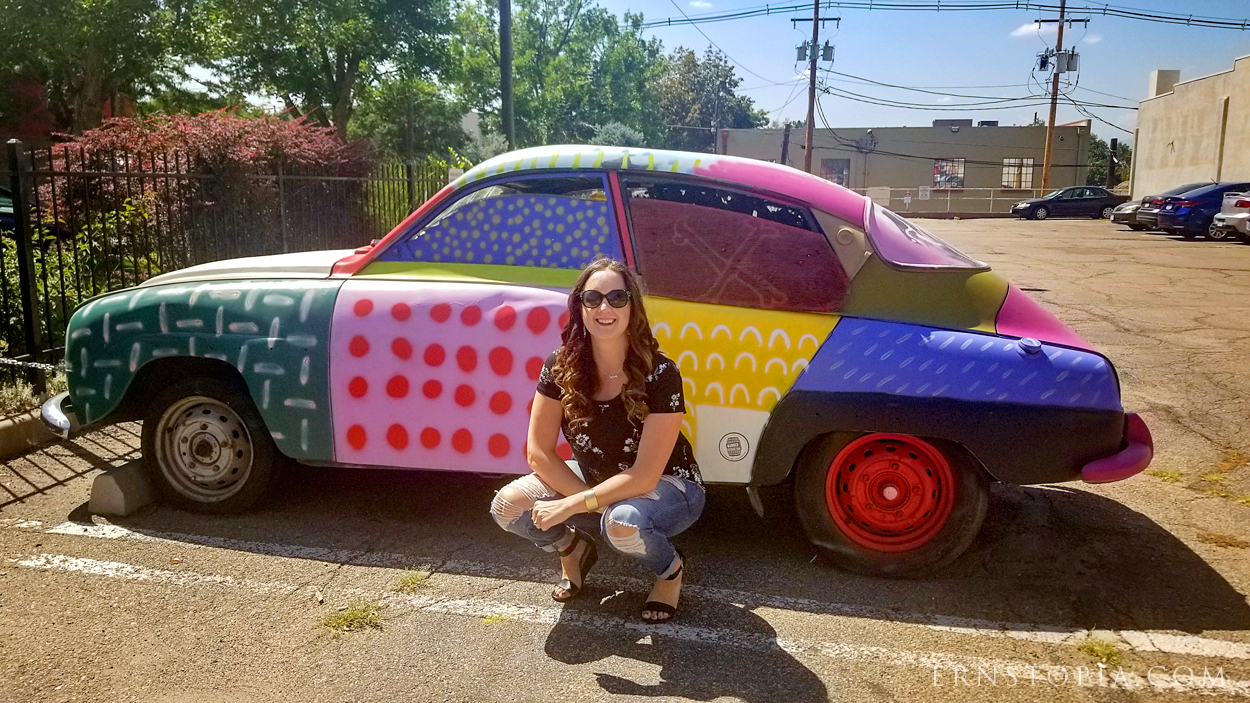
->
xmin=623 ymin=174 xmax=848 ymax=483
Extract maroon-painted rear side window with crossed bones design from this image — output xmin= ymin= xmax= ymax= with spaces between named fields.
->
xmin=623 ymin=176 xmax=848 ymax=313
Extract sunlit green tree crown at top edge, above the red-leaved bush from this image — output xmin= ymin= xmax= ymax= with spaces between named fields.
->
xmin=198 ymin=0 xmax=450 ymax=139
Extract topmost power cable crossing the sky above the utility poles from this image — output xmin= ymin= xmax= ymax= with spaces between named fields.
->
xmin=640 ymin=0 xmax=1250 ymax=31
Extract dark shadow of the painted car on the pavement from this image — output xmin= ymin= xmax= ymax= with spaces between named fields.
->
xmin=102 ymin=469 xmax=1250 ymax=633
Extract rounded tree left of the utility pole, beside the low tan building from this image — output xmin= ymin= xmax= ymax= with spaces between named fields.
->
xmin=653 ymin=46 xmax=769 ymax=151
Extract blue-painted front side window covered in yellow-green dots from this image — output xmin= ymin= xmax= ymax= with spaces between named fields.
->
xmin=378 ymin=174 xmax=621 ymax=269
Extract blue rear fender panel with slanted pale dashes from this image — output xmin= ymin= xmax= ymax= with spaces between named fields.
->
xmin=794 ymin=318 xmax=1123 ymax=410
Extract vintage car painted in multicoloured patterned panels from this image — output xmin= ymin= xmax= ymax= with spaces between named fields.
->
xmin=44 ymin=146 xmax=1153 ymax=575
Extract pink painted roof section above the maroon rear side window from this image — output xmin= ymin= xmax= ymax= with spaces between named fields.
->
xmin=695 ymin=156 xmax=868 ymax=229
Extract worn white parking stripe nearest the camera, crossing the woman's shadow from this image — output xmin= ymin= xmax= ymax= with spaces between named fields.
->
xmin=10 ymin=554 xmax=1250 ymax=698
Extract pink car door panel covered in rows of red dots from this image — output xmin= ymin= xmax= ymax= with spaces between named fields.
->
xmin=330 ymin=279 xmax=569 ymax=474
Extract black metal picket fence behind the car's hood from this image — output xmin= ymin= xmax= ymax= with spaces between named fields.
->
xmin=0 ymin=140 xmax=448 ymax=390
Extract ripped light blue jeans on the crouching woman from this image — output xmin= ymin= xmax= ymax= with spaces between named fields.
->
xmin=490 ymin=474 xmax=705 ymax=577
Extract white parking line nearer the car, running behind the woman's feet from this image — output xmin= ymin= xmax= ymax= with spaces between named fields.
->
xmin=24 ymin=523 xmax=1250 ymax=659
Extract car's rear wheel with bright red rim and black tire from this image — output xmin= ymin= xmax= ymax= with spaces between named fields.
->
xmin=795 ymin=433 xmax=989 ymax=577
